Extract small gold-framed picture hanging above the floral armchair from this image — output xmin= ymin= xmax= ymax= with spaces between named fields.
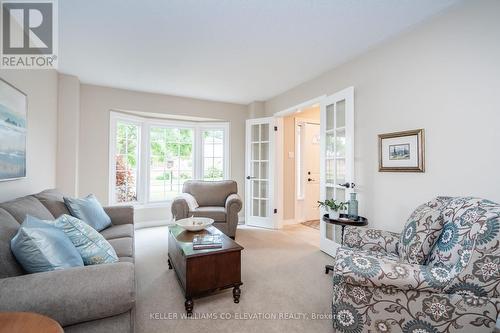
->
xmin=378 ymin=128 xmax=425 ymax=172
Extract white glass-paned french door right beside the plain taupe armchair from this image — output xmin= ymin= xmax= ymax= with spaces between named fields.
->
xmin=245 ymin=117 xmax=276 ymax=228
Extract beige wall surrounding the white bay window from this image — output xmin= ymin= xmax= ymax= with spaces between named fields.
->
xmin=79 ymin=84 xmax=248 ymax=220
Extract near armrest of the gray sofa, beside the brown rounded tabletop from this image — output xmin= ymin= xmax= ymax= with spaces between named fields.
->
xmin=0 ymin=262 xmax=135 ymax=326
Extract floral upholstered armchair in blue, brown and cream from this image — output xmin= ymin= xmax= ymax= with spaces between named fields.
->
xmin=332 ymin=197 xmax=500 ymax=333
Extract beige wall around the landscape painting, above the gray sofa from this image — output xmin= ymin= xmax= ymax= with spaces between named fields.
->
xmin=0 ymin=70 xmax=57 ymax=202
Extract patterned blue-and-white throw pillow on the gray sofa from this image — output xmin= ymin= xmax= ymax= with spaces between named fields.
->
xmin=48 ymin=214 xmax=118 ymax=265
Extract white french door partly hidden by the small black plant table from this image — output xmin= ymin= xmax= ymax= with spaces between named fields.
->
xmin=320 ymin=87 xmax=354 ymax=256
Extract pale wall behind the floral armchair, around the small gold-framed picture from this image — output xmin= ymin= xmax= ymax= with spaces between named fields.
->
xmin=265 ymin=0 xmax=500 ymax=232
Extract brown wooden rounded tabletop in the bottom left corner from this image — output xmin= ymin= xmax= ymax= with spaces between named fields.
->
xmin=0 ymin=312 xmax=64 ymax=333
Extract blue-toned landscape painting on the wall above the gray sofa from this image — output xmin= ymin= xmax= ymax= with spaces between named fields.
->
xmin=0 ymin=79 xmax=27 ymax=181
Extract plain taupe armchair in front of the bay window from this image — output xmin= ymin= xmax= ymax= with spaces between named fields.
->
xmin=172 ymin=180 xmax=242 ymax=239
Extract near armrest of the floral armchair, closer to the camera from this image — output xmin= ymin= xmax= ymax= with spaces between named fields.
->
xmin=333 ymin=248 xmax=453 ymax=292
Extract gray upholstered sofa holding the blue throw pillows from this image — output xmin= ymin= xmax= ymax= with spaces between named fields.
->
xmin=0 ymin=190 xmax=135 ymax=333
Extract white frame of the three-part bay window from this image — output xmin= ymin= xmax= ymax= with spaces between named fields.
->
xmin=108 ymin=111 xmax=231 ymax=206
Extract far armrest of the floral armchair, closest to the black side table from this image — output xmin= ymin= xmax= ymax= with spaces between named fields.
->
xmin=343 ymin=226 xmax=399 ymax=254
